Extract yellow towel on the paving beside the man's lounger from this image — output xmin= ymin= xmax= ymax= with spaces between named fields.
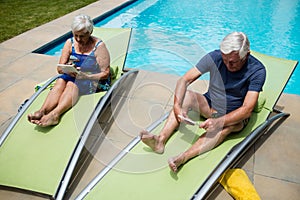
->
xmin=219 ymin=169 xmax=260 ymax=200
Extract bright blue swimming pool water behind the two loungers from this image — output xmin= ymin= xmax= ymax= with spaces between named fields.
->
xmin=44 ymin=0 xmax=300 ymax=95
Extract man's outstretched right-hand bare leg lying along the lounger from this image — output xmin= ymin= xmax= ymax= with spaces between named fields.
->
xmin=168 ymin=122 xmax=244 ymax=172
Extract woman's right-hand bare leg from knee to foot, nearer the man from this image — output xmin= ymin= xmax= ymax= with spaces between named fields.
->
xmin=37 ymin=81 xmax=79 ymax=127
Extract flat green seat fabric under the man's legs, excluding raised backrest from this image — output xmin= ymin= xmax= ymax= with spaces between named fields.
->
xmin=84 ymin=109 xmax=269 ymax=200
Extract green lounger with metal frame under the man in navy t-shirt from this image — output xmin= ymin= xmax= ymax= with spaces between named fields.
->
xmin=76 ymin=52 xmax=297 ymax=200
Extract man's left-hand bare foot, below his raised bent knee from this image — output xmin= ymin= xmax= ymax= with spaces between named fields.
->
xmin=140 ymin=130 xmax=165 ymax=154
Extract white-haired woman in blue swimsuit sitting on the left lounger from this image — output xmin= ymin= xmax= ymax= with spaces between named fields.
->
xmin=28 ymin=14 xmax=110 ymax=127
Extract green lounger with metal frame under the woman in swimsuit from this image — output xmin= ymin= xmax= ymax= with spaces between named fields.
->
xmin=0 ymin=28 xmax=131 ymax=199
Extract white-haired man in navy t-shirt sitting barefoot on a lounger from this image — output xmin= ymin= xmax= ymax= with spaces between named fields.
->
xmin=140 ymin=32 xmax=266 ymax=172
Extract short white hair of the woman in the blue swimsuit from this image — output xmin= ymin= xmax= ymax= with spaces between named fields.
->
xmin=71 ymin=14 xmax=94 ymax=34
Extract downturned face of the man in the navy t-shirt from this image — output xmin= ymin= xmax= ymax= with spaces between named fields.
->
xmin=222 ymin=51 xmax=248 ymax=72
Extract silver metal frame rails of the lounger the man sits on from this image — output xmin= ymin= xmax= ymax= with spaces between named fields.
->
xmin=76 ymin=54 xmax=298 ymax=200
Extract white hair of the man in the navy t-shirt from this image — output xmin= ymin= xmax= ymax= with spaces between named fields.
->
xmin=220 ymin=32 xmax=250 ymax=59
